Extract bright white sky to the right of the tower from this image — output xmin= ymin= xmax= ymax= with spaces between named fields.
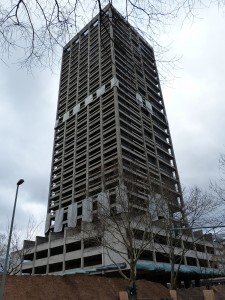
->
xmin=164 ymin=9 xmax=225 ymax=188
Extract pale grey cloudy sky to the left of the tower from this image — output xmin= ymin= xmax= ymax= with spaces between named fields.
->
xmin=0 ymin=63 xmax=58 ymax=230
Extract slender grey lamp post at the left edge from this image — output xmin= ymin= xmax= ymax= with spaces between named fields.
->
xmin=0 ymin=179 xmax=24 ymax=300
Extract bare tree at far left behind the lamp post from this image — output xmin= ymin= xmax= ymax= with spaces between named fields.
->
xmin=0 ymin=216 xmax=41 ymax=275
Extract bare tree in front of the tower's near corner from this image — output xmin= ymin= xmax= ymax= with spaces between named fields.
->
xmin=82 ymin=166 xmax=163 ymax=294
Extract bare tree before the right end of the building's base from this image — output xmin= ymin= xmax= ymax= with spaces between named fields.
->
xmin=158 ymin=187 xmax=221 ymax=289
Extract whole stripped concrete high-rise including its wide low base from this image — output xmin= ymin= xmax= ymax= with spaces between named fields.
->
xmin=19 ymin=6 xmax=220 ymax=282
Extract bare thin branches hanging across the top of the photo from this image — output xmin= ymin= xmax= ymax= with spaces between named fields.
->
xmin=0 ymin=0 xmax=224 ymax=68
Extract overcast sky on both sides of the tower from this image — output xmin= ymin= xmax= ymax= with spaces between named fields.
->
xmin=0 ymin=4 xmax=225 ymax=234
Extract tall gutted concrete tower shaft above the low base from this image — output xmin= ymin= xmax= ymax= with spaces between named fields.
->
xmin=46 ymin=7 xmax=181 ymax=232
